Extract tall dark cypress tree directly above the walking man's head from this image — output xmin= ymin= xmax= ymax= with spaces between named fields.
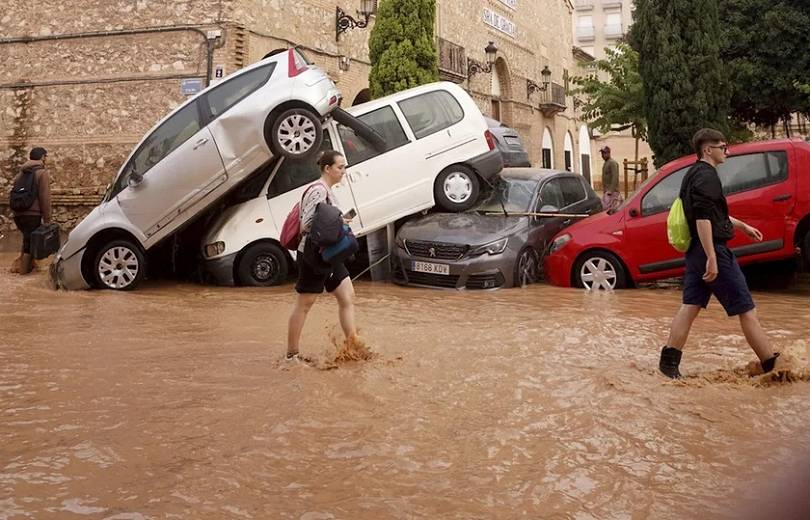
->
xmin=630 ymin=0 xmax=729 ymax=166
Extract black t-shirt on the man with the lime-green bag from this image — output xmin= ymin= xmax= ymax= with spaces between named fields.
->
xmin=680 ymin=161 xmax=734 ymax=244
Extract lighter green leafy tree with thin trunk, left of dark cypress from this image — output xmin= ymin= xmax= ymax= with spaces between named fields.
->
xmin=573 ymin=43 xmax=647 ymax=160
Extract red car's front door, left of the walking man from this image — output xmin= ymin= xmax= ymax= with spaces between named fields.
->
xmin=624 ymin=165 xmax=691 ymax=276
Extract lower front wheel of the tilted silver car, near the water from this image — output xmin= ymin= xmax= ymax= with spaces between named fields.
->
xmin=93 ymin=240 xmax=146 ymax=291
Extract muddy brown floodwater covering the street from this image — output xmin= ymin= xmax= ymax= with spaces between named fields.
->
xmin=0 ymin=255 xmax=810 ymax=520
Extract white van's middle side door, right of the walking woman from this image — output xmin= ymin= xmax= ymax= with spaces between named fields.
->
xmin=337 ymin=105 xmax=410 ymax=233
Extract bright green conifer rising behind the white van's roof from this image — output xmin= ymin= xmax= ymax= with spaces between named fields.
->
xmin=368 ymin=0 xmax=439 ymax=98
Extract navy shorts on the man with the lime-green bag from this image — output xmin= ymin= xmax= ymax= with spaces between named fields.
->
xmin=683 ymin=244 xmax=755 ymax=316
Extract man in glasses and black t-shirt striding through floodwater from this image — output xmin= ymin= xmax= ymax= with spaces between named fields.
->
xmin=658 ymin=128 xmax=779 ymax=379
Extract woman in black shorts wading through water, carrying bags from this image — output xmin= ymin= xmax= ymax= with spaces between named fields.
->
xmin=286 ymin=150 xmax=368 ymax=363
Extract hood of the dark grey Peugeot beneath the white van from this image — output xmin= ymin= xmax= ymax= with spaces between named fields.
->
xmin=397 ymin=213 xmax=528 ymax=245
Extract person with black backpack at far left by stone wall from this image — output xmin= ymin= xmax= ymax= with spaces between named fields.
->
xmin=9 ymin=147 xmax=51 ymax=274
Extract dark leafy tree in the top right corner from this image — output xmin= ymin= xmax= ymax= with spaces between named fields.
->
xmin=719 ymin=0 xmax=810 ymax=126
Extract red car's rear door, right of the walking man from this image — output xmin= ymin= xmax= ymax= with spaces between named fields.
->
xmin=717 ymin=150 xmax=795 ymax=256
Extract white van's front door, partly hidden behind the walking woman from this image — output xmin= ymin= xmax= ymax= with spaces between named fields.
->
xmin=266 ymin=125 xmax=360 ymax=237
